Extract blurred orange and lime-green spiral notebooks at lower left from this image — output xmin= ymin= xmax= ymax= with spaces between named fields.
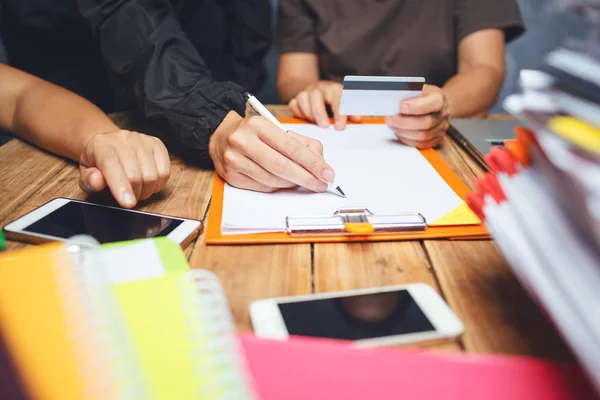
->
xmin=0 ymin=238 xmax=254 ymax=399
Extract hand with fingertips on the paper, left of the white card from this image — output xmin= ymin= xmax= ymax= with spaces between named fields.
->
xmin=288 ymin=81 xmax=361 ymax=130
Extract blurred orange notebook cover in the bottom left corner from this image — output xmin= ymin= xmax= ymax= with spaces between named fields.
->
xmin=0 ymin=243 xmax=114 ymax=400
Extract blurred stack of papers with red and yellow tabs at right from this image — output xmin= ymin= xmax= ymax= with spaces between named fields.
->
xmin=468 ymin=0 xmax=600 ymax=394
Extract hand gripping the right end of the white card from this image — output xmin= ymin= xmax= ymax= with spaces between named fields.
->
xmin=385 ymin=85 xmax=450 ymax=149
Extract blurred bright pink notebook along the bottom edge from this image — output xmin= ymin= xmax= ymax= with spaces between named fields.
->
xmin=240 ymin=335 xmax=598 ymax=400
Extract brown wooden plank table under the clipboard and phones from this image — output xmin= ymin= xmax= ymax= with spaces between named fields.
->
xmin=0 ymin=106 xmax=572 ymax=360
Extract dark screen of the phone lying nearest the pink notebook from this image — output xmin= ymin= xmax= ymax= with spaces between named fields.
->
xmin=278 ymin=290 xmax=435 ymax=340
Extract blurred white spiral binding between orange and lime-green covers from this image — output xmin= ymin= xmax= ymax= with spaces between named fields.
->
xmin=53 ymin=245 xmax=148 ymax=400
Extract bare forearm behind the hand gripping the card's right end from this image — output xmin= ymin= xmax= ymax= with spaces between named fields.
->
xmin=442 ymin=66 xmax=504 ymax=118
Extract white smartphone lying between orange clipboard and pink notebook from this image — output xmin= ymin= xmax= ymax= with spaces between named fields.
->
xmin=250 ymin=283 xmax=464 ymax=347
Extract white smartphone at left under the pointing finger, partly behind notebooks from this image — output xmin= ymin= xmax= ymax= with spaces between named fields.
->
xmin=4 ymin=198 xmax=203 ymax=247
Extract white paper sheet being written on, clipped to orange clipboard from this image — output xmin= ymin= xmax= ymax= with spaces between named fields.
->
xmin=221 ymin=124 xmax=462 ymax=234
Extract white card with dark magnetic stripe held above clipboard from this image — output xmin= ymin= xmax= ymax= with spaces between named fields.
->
xmin=340 ymin=75 xmax=425 ymax=116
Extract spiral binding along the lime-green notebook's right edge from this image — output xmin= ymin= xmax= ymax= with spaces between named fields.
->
xmin=180 ymin=270 xmax=256 ymax=400
